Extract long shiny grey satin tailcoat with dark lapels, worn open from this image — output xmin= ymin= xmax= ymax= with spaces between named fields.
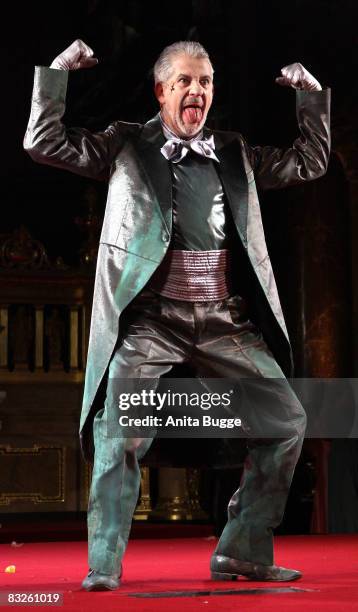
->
xmin=24 ymin=67 xmax=330 ymax=456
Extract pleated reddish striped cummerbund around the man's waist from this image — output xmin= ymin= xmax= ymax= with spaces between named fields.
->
xmin=147 ymin=249 xmax=231 ymax=302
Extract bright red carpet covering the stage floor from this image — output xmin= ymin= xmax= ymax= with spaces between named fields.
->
xmin=0 ymin=535 xmax=358 ymax=612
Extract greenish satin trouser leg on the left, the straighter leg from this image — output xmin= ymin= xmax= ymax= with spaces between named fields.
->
xmin=87 ymin=292 xmax=184 ymax=574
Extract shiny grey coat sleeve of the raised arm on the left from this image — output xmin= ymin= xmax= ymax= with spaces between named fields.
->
xmin=24 ymin=66 xmax=122 ymax=178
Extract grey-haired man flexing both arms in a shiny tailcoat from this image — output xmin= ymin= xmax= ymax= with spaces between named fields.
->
xmin=25 ymin=41 xmax=329 ymax=590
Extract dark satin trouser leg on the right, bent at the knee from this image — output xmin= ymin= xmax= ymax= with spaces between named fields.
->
xmin=196 ymin=298 xmax=306 ymax=565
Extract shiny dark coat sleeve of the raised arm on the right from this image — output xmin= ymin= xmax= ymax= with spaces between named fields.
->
xmin=244 ymin=89 xmax=331 ymax=189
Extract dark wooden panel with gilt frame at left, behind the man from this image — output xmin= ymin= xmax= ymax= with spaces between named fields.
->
xmin=0 ymin=383 xmax=87 ymax=513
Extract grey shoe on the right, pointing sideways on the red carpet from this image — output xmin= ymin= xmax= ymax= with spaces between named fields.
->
xmin=210 ymin=555 xmax=302 ymax=582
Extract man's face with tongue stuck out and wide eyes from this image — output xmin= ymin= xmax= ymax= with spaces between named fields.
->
xmin=155 ymin=54 xmax=214 ymax=138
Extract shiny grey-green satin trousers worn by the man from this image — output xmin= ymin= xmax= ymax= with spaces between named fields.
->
xmin=88 ymin=289 xmax=306 ymax=574
